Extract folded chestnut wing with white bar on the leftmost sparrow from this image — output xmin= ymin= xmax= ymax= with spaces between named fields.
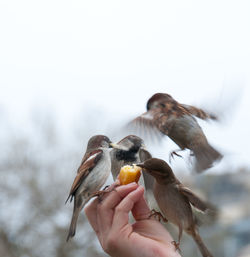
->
xmin=66 ymin=149 xmax=103 ymax=202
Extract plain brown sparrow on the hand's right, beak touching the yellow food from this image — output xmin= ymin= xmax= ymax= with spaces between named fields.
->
xmin=136 ymin=158 xmax=213 ymax=257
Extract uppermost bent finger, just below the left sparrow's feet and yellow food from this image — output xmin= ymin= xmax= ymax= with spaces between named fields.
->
xmin=97 ymin=183 xmax=138 ymax=235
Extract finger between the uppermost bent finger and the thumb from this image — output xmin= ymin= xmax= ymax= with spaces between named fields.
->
xmin=112 ymin=186 xmax=144 ymax=233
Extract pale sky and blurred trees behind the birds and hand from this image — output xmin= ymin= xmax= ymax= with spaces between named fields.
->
xmin=0 ymin=0 xmax=250 ymax=257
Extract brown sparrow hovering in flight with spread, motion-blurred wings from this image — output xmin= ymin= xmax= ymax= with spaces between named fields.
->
xmin=130 ymin=93 xmax=222 ymax=172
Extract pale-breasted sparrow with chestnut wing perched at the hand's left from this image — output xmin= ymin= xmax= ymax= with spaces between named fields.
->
xmin=65 ymin=135 xmax=112 ymax=241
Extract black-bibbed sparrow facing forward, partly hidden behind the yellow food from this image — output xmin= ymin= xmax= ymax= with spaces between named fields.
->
xmin=110 ymin=135 xmax=153 ymax=197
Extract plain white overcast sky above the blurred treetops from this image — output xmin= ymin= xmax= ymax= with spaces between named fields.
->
xmin=0 ymin=0 xmax=250 ymax=171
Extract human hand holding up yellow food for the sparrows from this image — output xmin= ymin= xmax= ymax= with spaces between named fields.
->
xmin=85 ymin=183 xmax=180 ymax=257
